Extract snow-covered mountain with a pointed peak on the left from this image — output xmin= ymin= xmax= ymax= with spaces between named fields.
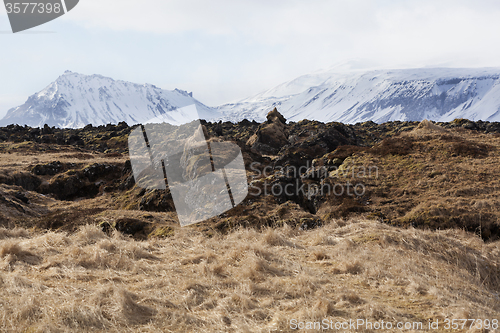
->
xmin=0 ymin=71 xmax=220 ymax=127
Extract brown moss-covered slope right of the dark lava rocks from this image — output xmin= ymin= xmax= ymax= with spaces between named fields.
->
xmin=322 ymin=123 xmax=500 ymax=239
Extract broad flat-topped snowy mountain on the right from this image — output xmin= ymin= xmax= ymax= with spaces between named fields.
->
xmin=219 ymin=68 xmax=500 ymax=123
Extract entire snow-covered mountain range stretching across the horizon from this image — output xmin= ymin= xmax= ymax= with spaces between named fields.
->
xmin=0 ymin=67 xmax=500 ymax=127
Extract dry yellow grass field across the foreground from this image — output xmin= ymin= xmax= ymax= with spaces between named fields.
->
xmin=0 ymin=220 xmax=500 ymax=332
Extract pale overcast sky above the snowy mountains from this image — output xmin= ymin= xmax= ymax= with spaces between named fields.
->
xmin=0 ymin=0 xmax=500 ymax=117
